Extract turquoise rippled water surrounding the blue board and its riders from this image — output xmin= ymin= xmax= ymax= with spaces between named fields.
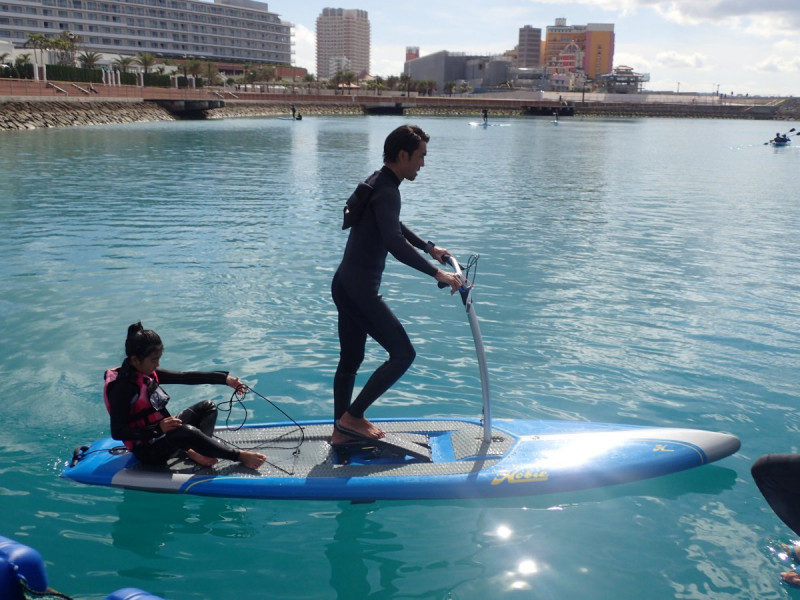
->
xmin=0 ymin=117 xmax=800 ymax=600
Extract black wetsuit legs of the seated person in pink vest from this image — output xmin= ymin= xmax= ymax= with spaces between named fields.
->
xmin=134 ymin=400 xmax=239 ymax=464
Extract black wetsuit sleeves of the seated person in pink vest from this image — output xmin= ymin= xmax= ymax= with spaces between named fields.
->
xmin=107 ymin=369 xmax=228 ymax=441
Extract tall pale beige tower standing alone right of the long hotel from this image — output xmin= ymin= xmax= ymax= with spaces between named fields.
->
xmin=317 ymin=8 xmax=370 ymax=79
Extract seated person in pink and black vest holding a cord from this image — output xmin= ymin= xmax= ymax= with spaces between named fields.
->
xmin=103 ymin=323 xmax=267 ymax=469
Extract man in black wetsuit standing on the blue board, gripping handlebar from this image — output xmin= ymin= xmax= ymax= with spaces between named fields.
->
xmin=331 ymin=125 xmax=461 ymax=444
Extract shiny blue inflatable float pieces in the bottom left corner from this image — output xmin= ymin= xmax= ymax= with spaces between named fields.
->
xmin=0 ymin=536 xmax=164 ymax=600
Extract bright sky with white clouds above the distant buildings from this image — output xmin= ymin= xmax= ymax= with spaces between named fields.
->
xmin=268 ymin=0 xmax=800 ymax=96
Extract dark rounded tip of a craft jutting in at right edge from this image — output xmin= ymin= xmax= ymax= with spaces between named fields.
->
xmin=750 ymin=454 xmax=800 ymax=535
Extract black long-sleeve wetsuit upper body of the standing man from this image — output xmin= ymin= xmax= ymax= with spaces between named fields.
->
xmin=338 ymin=166 xmax=437 ymax=291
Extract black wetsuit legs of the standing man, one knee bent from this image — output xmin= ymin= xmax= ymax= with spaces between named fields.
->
xmin=331 ymin=274 xmax=416 ymax=419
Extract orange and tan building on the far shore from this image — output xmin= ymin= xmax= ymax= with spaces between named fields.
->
xmin=544 ymin=18 xmax=614 ymax=79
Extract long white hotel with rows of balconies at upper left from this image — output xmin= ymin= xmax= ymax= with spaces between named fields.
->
xmin=0 ymin=0 xmax=293 ymax=65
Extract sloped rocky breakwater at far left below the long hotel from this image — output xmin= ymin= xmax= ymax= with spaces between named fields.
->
xmin=0 ymin=98 xmax=175 ymax=131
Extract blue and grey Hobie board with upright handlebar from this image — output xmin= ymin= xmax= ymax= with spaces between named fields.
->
xmin=61 ymin=258 xmax=739 ymax=501
